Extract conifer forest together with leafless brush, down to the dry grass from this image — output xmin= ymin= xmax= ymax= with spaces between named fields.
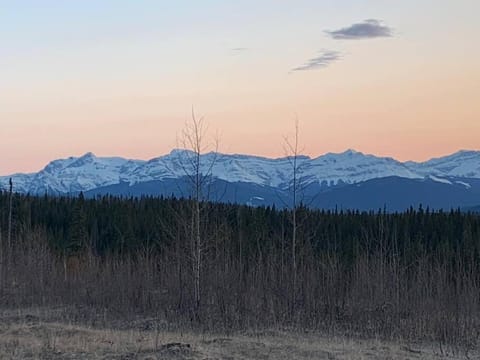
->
xmin=0 ymin=193 xmax=480 ymax=348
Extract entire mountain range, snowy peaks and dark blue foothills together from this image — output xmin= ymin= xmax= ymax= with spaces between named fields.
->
xmin=0 ymin=149 xmax=480 ymax=211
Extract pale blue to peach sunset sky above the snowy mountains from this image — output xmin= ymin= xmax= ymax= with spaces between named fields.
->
xmin=0 ymin=0 xmax=480 ymax=175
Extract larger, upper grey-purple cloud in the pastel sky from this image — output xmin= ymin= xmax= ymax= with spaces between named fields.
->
xmin=325 ymin=19 xmax=393 ymax=40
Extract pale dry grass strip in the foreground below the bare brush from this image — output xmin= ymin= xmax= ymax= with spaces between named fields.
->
xmin=0 ymin=309 xmax=472 ymax=360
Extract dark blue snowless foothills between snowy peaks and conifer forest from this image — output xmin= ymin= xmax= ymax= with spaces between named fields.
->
xmin=85 ymin=177 xmax=480 ymax=212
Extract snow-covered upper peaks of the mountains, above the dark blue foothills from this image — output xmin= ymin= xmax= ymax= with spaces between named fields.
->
xmin=0 ymin=150 xmax=480 ymax=194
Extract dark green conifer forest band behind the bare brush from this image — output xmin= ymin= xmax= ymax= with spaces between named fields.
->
xmin=0 ymin=193 xmax=480 ymax=263
